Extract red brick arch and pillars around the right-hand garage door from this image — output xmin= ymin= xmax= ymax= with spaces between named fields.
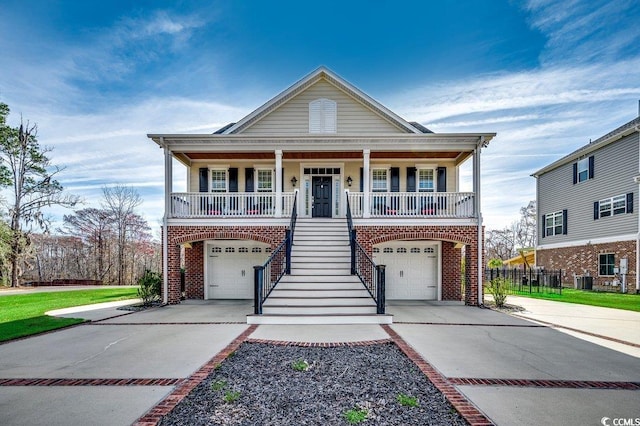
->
xmin=355 ymin=225 xmax=484 ymax=306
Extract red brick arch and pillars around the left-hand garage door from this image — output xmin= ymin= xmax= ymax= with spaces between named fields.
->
xmin=167 ymin=225 xmax=286 ymax=304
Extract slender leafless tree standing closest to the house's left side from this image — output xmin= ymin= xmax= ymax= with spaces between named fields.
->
xmin=102 ymin=185 xmax=142 ymax=285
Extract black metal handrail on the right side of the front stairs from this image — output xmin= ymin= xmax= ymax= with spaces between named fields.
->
xmin=347 ymin=192 xmax=386 ymax=314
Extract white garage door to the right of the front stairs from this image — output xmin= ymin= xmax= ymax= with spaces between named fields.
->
xmin=373 ymin=241 xmax=440 ymax=300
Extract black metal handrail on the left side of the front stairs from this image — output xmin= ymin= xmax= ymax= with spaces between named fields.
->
xmin=253 ymin=190 xmax=298 ymax=315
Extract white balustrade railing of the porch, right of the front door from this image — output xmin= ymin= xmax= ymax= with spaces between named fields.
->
xmin=347 ymin=192 xmax=476 ymax=218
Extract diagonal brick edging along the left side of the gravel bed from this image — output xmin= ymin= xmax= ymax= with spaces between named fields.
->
xmin=133 ymin=325 xmax=258 ymax=426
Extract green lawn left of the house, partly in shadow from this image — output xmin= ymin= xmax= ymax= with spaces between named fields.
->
xmin=0 ymin=287 xmax=138 ymax=342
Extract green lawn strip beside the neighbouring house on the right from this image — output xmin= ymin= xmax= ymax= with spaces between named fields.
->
xmin=517 ymin=288 xmax=640 ymax=312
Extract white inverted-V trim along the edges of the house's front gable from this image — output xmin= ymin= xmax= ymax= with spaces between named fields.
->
xmin=222 ymin=66 xmax=422 ymax=135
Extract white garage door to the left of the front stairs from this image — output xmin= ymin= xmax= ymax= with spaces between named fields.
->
xmin=205 ymin=240 xmax=271 ymax=299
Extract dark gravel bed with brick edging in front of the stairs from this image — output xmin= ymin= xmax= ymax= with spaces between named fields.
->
xmin=160 ymin=343 xmax=467 ymax=426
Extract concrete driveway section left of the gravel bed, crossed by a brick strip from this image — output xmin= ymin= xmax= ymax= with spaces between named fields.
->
xmin=0 ymin=302 xmax=251 ymax=426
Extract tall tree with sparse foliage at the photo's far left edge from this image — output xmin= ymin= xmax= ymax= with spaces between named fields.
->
xmin=0 ymin=104 xmax=79 ymax=287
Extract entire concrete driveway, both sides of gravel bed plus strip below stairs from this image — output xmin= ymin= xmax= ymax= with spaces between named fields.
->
xmin=0 ymin=301 xmax=640 ymax=425
